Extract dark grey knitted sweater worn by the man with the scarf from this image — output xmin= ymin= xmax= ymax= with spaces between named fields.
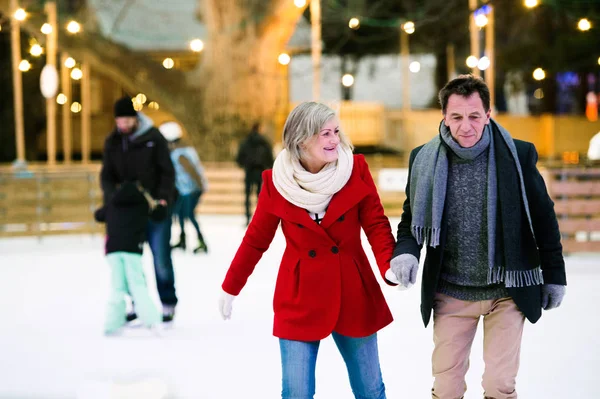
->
xmin=438 ymin=150 xmax=508 ymax=301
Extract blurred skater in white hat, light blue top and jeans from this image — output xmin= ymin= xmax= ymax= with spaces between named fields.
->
xmin=158 ymin=122 xmax=208 ymax=253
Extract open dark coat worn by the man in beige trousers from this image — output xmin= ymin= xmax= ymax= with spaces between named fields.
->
xmin=394 ymin=140 xmax=567 ymax=326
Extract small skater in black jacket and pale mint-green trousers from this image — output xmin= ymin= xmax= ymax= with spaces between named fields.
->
xmin=94 ymin=182 xmax=161 ymax=335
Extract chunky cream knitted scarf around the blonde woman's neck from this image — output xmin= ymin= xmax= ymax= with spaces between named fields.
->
xmin=273 ymin=144 xmax=354 ymax=213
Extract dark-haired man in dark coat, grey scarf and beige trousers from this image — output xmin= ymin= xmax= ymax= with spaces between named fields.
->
xmin=391 ymin=75 xmax=566 ymax=399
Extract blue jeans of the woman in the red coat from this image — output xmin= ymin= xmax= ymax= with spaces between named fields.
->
xmin=279 ymin=332 xmax=385 ymax=399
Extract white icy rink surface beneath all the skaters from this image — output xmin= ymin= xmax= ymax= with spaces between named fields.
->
xmin=0 ymin=216 xmax=600 ymax=399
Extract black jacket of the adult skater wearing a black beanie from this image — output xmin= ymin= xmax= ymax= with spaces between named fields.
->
xmin=100 ymin=114 xmax=175 ymax=204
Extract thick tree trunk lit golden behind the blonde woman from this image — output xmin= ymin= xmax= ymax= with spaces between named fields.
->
xmin=196 ymin=0 xmax=303 ymax=159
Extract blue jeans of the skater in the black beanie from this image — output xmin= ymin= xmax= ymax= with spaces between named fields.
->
xmin=146 ymin=215 xmax=177 ymax=306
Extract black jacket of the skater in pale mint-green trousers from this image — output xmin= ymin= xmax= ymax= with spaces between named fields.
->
xmin=94 ymin=182 xmax=149 ymax=254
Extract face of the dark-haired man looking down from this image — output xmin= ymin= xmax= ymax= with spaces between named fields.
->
xmin=444 ymin=92 xmax=490 ymax=148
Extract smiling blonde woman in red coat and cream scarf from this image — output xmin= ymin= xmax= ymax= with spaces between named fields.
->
xmin=219 ymin=102 xmax=395 ymax=399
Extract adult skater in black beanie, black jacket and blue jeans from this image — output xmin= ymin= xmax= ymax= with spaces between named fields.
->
xmin=101 ymin=97 xmax=177 ymax=321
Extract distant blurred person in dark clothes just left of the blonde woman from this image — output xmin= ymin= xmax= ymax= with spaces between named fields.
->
xmin=236 ymin=123 xmax=273 ymax=226
